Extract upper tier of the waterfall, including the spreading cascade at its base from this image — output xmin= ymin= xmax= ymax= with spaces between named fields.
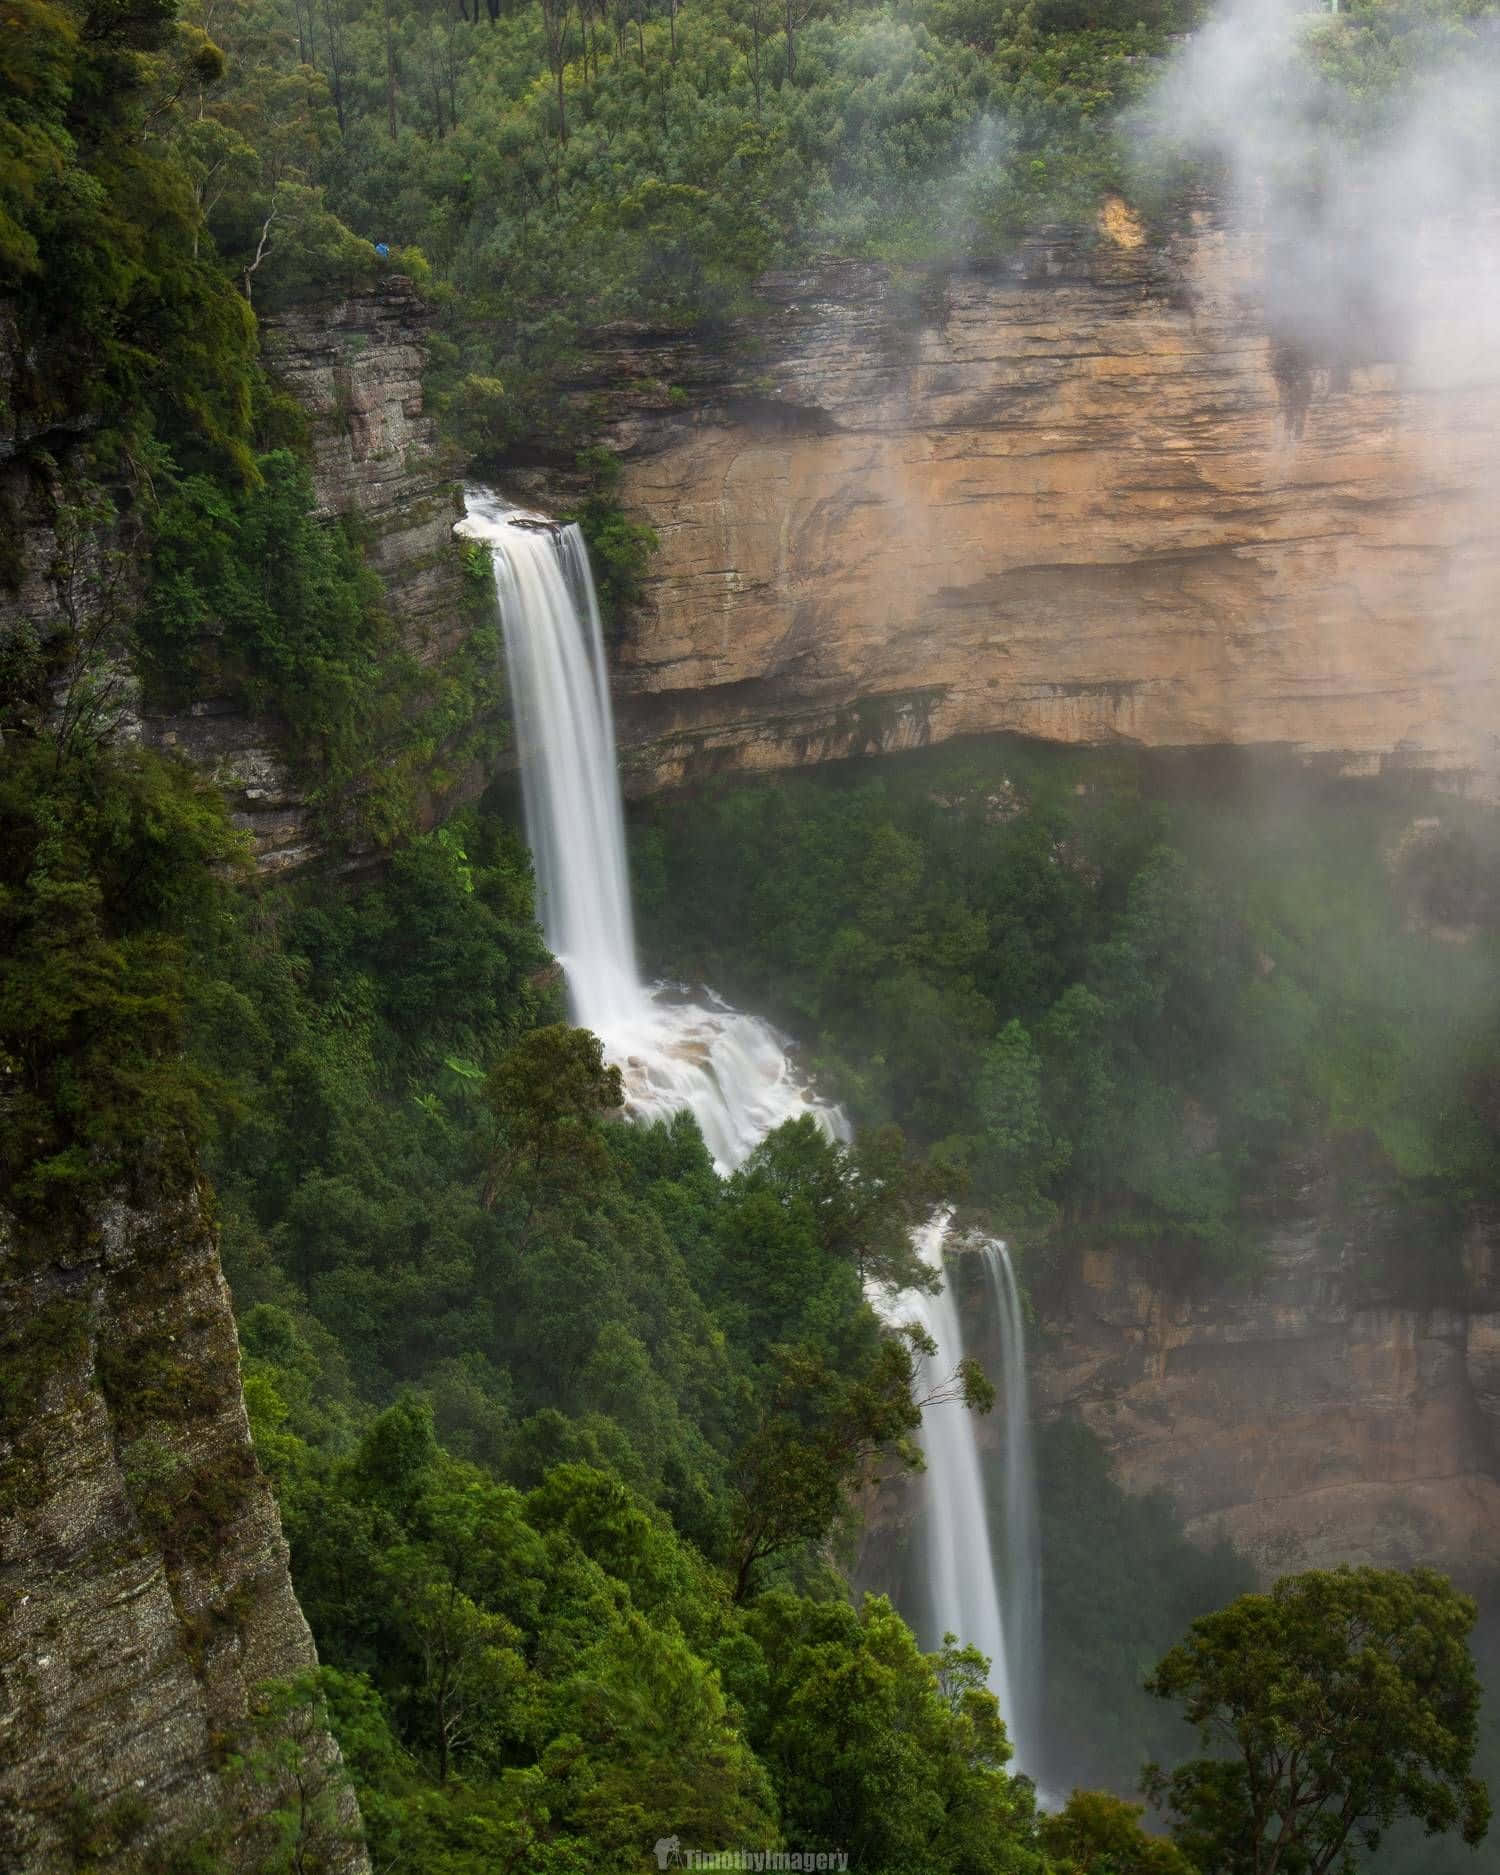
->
xmin=458 ymin=489 xmax=848 ymax=1172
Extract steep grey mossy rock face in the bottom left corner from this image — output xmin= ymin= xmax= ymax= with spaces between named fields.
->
xmin=0 ymin=1194 xmax=368 ymax=1875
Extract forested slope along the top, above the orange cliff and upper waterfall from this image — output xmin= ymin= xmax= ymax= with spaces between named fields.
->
xmin=122 ymin=0 xmax=1207 ymax=450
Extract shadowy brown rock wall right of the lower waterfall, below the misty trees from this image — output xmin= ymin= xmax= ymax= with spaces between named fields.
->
xmin=1033 ymin=1164 xmax=1500 ymax=1581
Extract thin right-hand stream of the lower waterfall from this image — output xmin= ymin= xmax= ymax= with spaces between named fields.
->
xmin=981 ymin=1238 xmax=1043 ymax=1746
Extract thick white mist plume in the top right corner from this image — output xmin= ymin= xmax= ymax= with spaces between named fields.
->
xmin=1134 ymin=0 xmax=1500 ymax=384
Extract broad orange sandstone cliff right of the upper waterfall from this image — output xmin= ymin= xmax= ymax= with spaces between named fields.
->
xmin=555 ymin=219 xmax=1500 ymax=791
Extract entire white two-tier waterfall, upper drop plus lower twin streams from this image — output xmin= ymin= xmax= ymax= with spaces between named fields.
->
xmin=458 ymin=489 xmax=1041 ymax=1764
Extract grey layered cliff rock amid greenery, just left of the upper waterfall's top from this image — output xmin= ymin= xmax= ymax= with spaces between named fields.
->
xmin=148 ymin=276 xmax=468 ymax=872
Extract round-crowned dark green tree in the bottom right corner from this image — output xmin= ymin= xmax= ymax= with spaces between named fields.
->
xmin=1146 ymin=1568 xmax=1489 ymax=1875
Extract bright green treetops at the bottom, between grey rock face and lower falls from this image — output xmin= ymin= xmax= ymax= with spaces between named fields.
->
xmin=255 ymin=1365 xmax=1039 ymax=1875
